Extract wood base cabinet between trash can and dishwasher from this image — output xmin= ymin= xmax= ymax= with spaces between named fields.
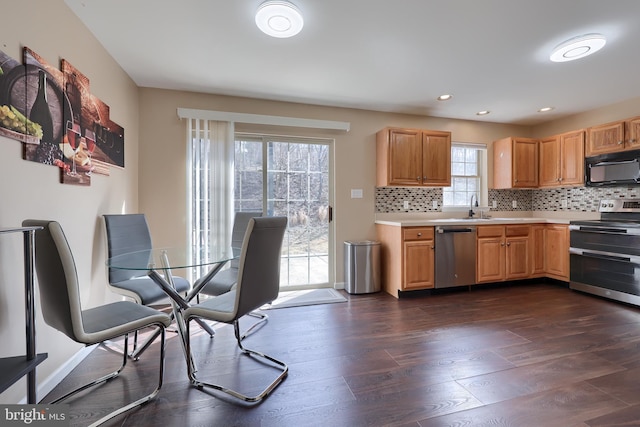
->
xmin=376 ymin=224 xmax=435 ymax=298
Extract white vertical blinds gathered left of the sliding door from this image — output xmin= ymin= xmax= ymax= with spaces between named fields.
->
xmin=187 ymin=119 xmax=235 ymax=281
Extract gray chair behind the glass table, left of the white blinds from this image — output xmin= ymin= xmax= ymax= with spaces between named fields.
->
xmin=103 ymin=214 xmax=191 ymax=305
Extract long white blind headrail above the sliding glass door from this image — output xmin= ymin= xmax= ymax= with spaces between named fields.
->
xmin=178 ymin=108 xmax=351 ymax=132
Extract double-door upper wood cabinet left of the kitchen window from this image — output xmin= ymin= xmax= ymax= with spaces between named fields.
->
xmin=376 ymin=128 xmax=451 ymax=187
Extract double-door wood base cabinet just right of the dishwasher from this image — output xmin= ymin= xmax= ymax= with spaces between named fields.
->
xmin=476 ymin=224 xmax=531 ymax=283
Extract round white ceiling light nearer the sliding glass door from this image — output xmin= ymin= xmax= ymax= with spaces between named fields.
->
xmin=256 ymin=0 xmax=304 ymax=38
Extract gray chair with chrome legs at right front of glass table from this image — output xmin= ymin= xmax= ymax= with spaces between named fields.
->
xmin=183 ymin=217 xmax=289 ymax=402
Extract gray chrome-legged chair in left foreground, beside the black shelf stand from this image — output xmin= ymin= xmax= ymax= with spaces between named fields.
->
xmin=22 ymin=220 xmax=171 ymax=425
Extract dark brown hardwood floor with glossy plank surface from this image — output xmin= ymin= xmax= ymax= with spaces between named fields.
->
xmin=44 ymin=283 xmax=640 ymax=427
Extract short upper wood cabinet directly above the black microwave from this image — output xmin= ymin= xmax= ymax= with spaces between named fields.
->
xmin=586 ymin=117 xmax=640 ymax=156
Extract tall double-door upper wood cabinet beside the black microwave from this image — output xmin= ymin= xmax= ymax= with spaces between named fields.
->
xmin=538 ymin=130 xmax=584 ymax=187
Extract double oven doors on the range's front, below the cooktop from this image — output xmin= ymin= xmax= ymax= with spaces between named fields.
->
xmin=569 ymin=226 xmax=640 ymax=306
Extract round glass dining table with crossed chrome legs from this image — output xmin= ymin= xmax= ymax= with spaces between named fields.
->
xmin=107 ymin=248 xmax=235 ymax=372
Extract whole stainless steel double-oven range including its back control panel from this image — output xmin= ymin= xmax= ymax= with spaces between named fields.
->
xmin=569 ymin=199 xmax=640 ymax=306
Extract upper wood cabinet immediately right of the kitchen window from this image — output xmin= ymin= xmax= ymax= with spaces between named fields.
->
xmin=493 ymin=137 xmax=538 ymax=189
